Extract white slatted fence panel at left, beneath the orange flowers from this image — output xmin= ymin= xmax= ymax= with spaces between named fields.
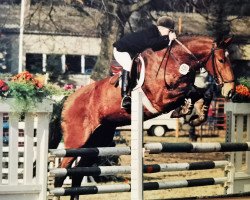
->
xmin=0 ymin=101 xmax=52 ymax=200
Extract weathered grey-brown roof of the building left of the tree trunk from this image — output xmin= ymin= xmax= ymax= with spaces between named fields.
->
xmin=0 ymin=5 xmax=100 ymax=37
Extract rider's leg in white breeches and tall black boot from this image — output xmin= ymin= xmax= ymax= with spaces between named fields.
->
xmin=113 ymin=48 xmax=132 ymax=109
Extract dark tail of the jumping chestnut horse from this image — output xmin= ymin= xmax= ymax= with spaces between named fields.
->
xmin=49 ymin=96 xmax=67 ymax=149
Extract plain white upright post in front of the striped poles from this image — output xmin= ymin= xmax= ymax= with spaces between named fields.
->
xmin=131 ymin=89 xmax=143 ymax=200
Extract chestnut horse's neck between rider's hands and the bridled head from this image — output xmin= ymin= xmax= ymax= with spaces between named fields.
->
xmin=144 ymin=37 xmax=212 ymax=90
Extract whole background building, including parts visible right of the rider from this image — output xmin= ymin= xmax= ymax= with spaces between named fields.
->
xmin=0 ymin=4 xmax=250 ymax=85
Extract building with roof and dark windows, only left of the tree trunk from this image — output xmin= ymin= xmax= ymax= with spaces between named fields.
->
xmin=0 ymin=5 xmax=101 ymax=85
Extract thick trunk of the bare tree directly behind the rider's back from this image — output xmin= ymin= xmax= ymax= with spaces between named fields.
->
xmin=70 ymin=0 xmax=151 ymax=80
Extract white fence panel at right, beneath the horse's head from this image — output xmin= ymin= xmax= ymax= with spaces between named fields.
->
xmin=224 ymin=102 xmax=250 ymax=193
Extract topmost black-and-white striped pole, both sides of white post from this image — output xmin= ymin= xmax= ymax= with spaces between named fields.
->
xmin=49 ymin=142 xmax=250 ymax=157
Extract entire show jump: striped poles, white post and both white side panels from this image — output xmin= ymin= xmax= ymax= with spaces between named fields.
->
xmin=0 ymin=90 xmax=250 ymax=200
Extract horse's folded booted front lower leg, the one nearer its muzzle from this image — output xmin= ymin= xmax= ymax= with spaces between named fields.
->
xmin=189 ymin=89 xmax=213 ymax=126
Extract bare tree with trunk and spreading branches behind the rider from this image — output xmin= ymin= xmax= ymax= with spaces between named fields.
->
xmin=20 ymin=0 xmax=152 ymax=80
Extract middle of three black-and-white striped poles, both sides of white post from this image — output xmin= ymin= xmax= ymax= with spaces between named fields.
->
xmin=50 ymin=160 xmax=229 ymax=177
